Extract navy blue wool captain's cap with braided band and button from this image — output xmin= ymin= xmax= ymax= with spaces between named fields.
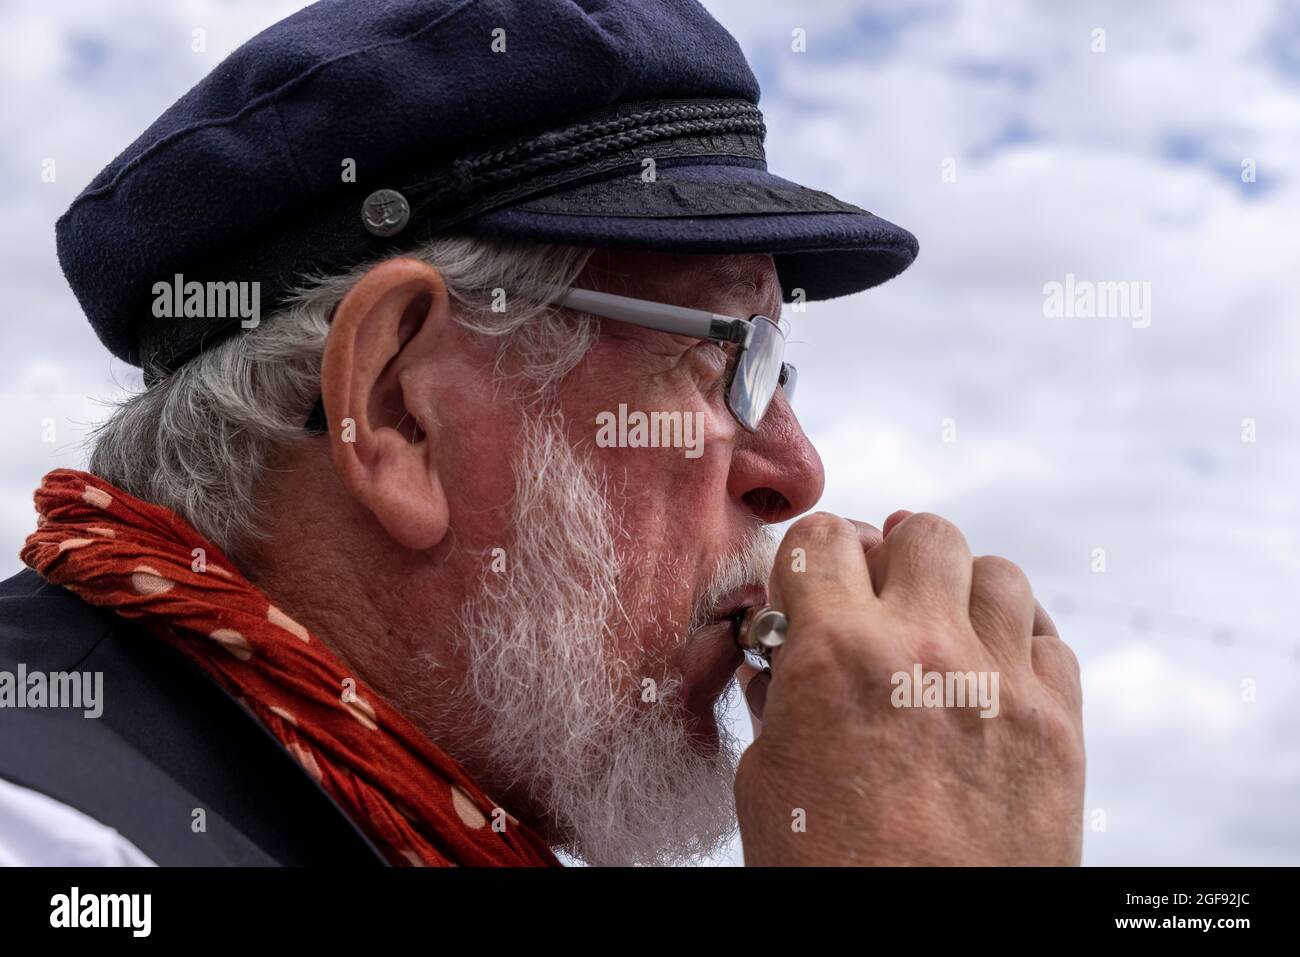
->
xmin=56 ymin=0 xmax=917 ymax=380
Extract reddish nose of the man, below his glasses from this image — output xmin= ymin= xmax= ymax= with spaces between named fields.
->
xmin=727 ymin=393 xmax=826 ymax=523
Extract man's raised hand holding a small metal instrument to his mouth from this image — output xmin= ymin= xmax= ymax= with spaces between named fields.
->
xmin=736 ymin=512 xmax=1084 ymax=865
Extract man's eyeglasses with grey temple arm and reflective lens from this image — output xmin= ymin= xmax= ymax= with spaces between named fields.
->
xmin=304 ymin=289 xmax=798 ymax=432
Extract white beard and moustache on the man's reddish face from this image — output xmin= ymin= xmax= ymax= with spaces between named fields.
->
xmin=411 ymin=416 xmax=776 ymax=865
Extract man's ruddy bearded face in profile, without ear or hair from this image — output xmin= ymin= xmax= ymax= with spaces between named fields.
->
xmin=313 ymin=254 xmax=823 ymax=863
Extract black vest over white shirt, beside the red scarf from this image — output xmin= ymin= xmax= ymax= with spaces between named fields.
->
xmin=0 ymin=568 xmax=385 ymax=866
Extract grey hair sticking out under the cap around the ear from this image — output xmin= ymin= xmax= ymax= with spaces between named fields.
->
xmin=90 ymin=237 xmax=597 ymax=555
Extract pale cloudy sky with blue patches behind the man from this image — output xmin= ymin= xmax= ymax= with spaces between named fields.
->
xmin=0 ymin=0 xmax=1300 ymax=865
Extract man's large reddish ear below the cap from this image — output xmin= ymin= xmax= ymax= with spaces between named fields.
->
xmin=321 ymin=259 xmax=452 ymax=550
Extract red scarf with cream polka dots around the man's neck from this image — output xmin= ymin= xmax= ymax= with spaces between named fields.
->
xmin=22 ymin=468 xmax=559 ymax=866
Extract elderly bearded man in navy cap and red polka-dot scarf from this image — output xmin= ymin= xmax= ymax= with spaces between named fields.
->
xmin=0 ymin=0 xmax=1084 ymax=865
